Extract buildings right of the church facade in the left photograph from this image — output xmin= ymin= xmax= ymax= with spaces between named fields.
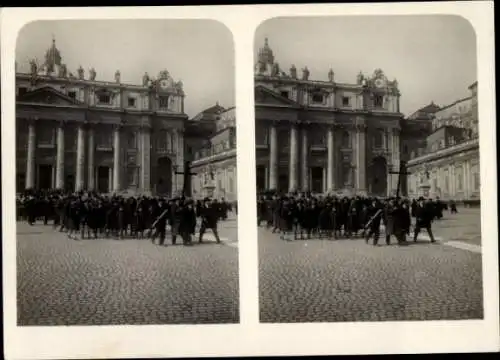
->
xmin=188 ymin=104 xmax=238 ymax=202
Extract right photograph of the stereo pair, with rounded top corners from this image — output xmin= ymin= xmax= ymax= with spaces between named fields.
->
xmin=254 ymin=15 xmax=482 ymax=323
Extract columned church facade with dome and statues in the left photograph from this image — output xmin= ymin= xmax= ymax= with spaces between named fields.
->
xmin=16 ymin=40 xmax=188 ymax=195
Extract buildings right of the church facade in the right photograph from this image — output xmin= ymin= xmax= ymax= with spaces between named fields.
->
xmin=408 ymin=82 xmax=480 ymax=201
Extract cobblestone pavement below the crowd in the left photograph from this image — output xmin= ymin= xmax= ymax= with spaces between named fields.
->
xmin=17 ymin=221 xmax=239 ymax=325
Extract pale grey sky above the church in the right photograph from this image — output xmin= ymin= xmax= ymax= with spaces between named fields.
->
xmin=254 ymin=16 xmax=477 ymax=115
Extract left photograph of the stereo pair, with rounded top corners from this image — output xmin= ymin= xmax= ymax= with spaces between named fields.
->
xmin=13 ymin=20 xmax=239 ymax=324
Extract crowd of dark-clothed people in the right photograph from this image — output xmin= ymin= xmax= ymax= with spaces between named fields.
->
xmin=257 ymin=191 xmax=457 ymax=246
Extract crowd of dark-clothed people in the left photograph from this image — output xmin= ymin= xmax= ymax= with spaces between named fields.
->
xmin=16 ymin=189 xmax=237 ymax=246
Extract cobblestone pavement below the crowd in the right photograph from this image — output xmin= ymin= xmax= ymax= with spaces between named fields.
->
xmin=259 ymin=221 xmax=483 ymax=322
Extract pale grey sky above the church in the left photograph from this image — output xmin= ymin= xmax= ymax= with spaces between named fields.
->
xmin=16 ymin=20 xmax=235 ymax=117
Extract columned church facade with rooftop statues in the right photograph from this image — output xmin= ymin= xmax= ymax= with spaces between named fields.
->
xmin=254 ymin=39 xmax=412 ymax=196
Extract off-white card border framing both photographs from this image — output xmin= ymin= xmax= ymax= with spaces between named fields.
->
xmin=0 ymin=1 xmax=500 ymax=359
